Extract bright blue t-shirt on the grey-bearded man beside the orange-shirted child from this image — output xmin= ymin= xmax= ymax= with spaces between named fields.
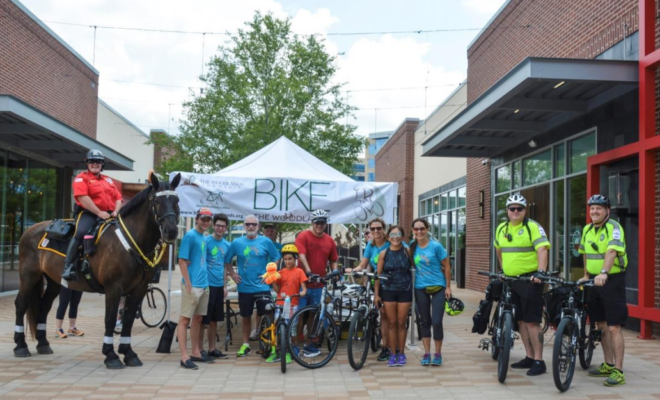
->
xmin=225 ymin=236 xmax=280 ymax=293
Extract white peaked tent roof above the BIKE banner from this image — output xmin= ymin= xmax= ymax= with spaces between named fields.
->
xmin=213 ymin=136 xmax=353 ymax=182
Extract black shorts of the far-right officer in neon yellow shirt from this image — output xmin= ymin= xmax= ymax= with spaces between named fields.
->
xmin=586 ymin=272 xmax=628 ymax=326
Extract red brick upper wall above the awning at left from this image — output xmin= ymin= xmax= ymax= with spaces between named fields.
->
xmin=0 ymin=0 xmax=98 ymax=138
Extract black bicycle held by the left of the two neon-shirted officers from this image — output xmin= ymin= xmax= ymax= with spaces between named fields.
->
xmin=478 ymin=271 xmax=530 ymax=383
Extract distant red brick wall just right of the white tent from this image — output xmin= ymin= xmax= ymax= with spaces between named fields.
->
xmin=375 ymin=120 xmax=419 ymax=235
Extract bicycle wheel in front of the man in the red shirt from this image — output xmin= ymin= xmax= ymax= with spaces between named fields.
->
xmin=291 ymin=306 xmax=339 ymax=369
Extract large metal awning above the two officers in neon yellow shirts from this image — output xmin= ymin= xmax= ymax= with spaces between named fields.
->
xmin=422 ymin=58 xmax=639 ymax=157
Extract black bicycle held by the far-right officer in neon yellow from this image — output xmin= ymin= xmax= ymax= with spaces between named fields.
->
xmin=542 ymin=277 xmax=602 ymax=392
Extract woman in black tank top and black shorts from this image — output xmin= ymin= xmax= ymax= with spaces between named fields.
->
xmin=374 ymin=225 xmax=412 ymax=367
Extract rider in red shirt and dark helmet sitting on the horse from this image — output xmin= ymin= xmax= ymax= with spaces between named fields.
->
xmin=62 ymin=149 xmax=122 ymax=281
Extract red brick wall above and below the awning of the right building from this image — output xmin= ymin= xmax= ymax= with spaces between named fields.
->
xmin=466 ymin=0 xmax=640 ymax=290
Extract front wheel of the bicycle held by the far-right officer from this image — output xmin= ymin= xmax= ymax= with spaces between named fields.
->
xmin=552 ymin=318 xmax=577 ymax=392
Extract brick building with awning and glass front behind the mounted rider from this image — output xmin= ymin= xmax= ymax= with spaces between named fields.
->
xmin=0 ymin=0 xmax=133 ymax=291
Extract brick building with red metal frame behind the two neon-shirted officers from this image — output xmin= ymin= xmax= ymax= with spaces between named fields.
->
xmin=423 ymin=0 xmax=660 ymax=337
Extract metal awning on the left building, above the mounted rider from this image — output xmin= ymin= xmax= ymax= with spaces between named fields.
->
xmin=0 ymin=95 xmax=133 ymax=171
